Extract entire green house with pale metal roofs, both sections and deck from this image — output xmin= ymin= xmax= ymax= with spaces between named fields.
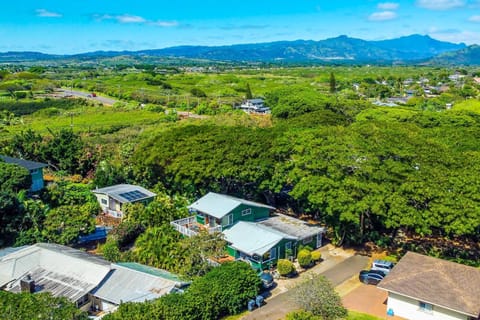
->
xmin=171 ymin=192 xmax=325 ymax=269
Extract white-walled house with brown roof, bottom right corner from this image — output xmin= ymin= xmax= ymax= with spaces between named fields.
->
xmin=378 ymin=252 xmax=480 ymax=320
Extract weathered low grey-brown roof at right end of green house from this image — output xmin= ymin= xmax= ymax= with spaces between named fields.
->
xmin=258 ymin=213 xmax=325 ymax=240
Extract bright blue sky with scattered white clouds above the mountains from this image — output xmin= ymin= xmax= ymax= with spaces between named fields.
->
xmin=0 ymin=0 xmax=480 ymax=54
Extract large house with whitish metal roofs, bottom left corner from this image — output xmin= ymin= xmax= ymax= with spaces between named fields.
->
xmin=0 ymin=243 xmax=182 ymax=314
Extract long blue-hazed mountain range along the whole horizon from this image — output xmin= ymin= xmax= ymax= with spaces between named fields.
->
xmin=0 ymin=35 xmax=480 ymax=65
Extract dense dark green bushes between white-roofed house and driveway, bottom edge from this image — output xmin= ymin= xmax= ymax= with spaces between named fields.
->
xmin=104 ymin=261 xmax=261 ymax=320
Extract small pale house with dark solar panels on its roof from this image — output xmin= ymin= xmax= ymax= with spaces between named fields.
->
xmin=92 ymin=184 xmax=156 ymax=218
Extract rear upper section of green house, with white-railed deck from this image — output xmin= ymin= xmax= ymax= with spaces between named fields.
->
xmin=171 ymin=192 xmax=275 ymax=236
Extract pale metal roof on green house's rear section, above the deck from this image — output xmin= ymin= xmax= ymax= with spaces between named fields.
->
xmin=188 ymin=192 xmax=275 ymax=219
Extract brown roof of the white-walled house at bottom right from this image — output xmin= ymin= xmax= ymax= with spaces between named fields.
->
xmin=378 ymin=252 xmax=480 ymax=318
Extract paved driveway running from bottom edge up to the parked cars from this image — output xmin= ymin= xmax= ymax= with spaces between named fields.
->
xmin=242 ymin=247 xmax=369 ymax=320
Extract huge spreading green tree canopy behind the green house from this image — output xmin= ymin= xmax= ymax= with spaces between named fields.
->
xmin=127 ymin=88 xmax=480 ymax=262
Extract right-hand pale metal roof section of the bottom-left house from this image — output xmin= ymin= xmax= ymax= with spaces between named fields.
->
xmin=92 ymin=264 xmax=177 ymax=304
